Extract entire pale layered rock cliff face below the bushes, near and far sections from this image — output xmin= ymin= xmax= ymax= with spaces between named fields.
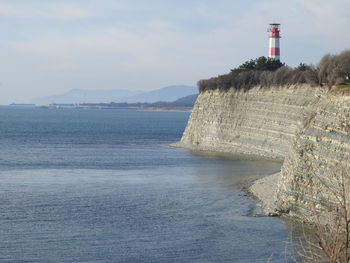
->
xmin=180 ymin=86 xmax=350 ymax=222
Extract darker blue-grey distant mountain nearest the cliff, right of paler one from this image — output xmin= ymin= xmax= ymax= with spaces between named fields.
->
xmin=123 ymin=85 xmax=198 ymax=103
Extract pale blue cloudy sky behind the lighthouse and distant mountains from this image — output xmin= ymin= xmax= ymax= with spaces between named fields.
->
xmin=0 ymin=0 xmax=350 ymax=104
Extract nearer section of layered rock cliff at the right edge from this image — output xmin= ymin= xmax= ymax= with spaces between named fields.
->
xmin=276 ymin=93 xmax=350 ymax=220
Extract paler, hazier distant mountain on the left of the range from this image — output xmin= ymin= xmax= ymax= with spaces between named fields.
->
xmin=31 ymin=89 xmax=144 ymax=105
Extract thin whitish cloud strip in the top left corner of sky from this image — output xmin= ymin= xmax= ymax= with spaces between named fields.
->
xmin=0 ymin=2 xmax=94 ymax=20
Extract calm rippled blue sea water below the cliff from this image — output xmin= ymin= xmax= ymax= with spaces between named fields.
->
xmin=0 ymin=108 xmax=296 ymax=262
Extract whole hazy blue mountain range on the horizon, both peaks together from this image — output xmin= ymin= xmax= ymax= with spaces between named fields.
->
xmin=31 ymin=85 xmax=198 ymax=105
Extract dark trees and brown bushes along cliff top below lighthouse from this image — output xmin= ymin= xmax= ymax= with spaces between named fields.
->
xmin=198 ymin=50 xmax=350 ymax=92
